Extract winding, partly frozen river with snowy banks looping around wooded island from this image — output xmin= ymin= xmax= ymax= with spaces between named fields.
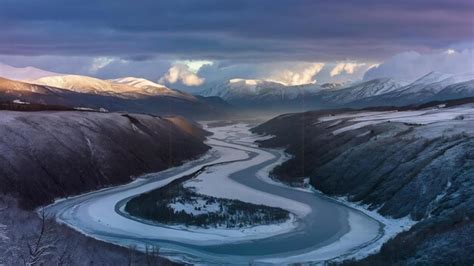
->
xmin=46 ymin=124 xmax=411 ymax=265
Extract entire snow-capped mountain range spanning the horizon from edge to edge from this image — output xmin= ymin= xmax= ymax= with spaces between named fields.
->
xmin=0 ymin=62 xmax=474 ymax=119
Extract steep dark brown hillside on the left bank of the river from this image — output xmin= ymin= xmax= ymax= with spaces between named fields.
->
xmin=0 ymin=111 xmax=208 ymax=208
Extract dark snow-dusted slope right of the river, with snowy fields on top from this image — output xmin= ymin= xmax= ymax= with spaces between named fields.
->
xmin=254 ymin=100 xmax=474 ymax=265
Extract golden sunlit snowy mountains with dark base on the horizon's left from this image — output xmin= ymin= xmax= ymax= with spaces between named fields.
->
xmin=0 ymin=75 xmax=233 ymax=119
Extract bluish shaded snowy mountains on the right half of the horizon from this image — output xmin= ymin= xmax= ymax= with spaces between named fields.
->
xmin=202 ymin=72 xmax=474 ymax=110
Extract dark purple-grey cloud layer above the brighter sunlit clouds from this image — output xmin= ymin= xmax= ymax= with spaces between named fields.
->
xmin=0 ymin=0 xmax=474 ymax=61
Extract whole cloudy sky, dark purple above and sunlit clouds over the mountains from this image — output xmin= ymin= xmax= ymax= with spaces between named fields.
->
xmin=0 ymin=0 xmax=474 ymax=89
